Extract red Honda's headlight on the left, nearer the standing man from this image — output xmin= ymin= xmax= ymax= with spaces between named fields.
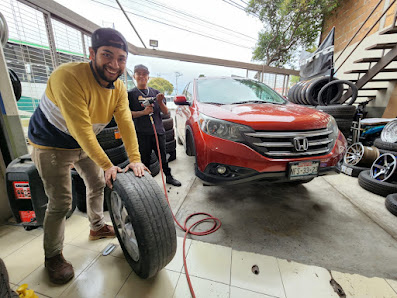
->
xmin=199 ymin=113 xmax=255 ymax=142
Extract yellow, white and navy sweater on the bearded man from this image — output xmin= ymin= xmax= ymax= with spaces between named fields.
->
xmin=28 ymin=62 xmax=140 ymax=171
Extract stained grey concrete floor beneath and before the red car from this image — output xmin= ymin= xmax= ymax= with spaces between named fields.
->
xmin=156 ymin=141 xmax=397 ymax=279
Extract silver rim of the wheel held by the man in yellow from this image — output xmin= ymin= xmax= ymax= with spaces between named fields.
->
xmin=110 ymin=191 xmax=139 ymax=262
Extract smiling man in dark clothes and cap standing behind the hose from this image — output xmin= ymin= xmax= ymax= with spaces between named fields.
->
xmin=128 ymin=64 xmax=181 ymax=186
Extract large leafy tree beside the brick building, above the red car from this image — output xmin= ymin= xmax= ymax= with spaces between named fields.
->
xmin=246 ymin=0 xmax=340 ymax=67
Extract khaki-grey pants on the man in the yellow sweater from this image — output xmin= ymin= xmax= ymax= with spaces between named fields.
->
xmin=32 ymin=148 xmax=105 ymax=258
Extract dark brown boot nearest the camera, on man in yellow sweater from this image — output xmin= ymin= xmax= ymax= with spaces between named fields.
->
xmin=44 ymin=253 xmax=74 ymax=285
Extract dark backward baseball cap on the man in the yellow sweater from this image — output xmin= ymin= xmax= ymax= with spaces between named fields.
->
xmin=91 ymin=28 xmax=128 ymax=54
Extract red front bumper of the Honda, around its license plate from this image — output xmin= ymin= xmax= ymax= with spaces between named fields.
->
xmin=195 ymin=133 xmax=346 ymax=184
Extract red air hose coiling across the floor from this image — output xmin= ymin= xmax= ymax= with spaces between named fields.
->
xmin=149 ymin=115 xmax=222 ymax=298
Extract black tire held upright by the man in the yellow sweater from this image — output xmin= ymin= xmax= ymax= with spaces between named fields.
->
xmin=106 ymin=172 xmax=177 ymax=278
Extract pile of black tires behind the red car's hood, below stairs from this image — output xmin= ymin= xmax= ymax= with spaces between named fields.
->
xmin=288 ymin=76 xmax=357 ymax=138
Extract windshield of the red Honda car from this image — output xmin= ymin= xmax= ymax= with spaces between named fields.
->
xmin=197 ymin=78 xmax=286 ymax=104
